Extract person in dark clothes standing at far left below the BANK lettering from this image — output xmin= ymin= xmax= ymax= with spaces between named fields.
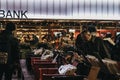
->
xmin=0 ymin=22 xmax=19 ymax=80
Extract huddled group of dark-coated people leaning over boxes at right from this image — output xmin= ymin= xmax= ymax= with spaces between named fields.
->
xmin=76 ymin=27 xmax=120 ymax=61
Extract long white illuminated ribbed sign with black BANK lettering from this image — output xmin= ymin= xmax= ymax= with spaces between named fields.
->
xmin=0 ymin=0 xmax=120 ymax=20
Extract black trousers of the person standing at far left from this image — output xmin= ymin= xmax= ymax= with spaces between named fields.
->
xmin=0 ymin=64 xmax=14 ymax=80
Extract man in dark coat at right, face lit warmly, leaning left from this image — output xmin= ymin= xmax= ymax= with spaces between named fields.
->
xmin=82 ymin=30 xmax=110 ymax=59
